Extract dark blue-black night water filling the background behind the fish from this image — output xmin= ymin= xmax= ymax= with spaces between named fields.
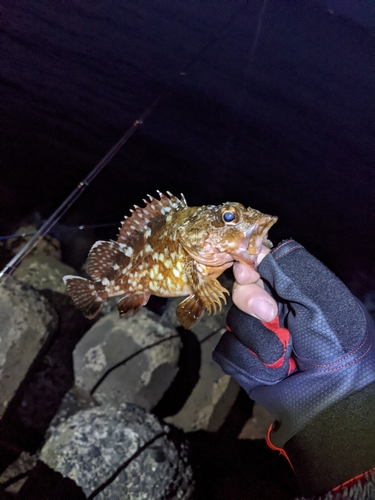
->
xmin=1 ymin=0 xmax=375 ymax=288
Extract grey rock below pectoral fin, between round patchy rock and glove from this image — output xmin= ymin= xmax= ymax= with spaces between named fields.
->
xmin=164 ymin=276 xmax=239 ymax=432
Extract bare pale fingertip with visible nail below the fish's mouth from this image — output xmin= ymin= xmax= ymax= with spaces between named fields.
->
xmin=232 ymin=283 xmax=277 ymax=323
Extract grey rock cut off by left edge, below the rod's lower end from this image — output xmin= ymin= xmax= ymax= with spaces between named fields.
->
xmin=0 ymin=276 xmax=58 ymax=418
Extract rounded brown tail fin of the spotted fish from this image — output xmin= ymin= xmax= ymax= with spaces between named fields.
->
xmin=63 ymin=275 xmax=108 ymax=319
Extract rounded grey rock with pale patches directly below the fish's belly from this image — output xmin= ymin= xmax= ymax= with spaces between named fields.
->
xmin=73 ymin=308 xmax=180 ymax=410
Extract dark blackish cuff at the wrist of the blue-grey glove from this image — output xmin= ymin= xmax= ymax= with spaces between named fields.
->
xmin=284 ymin=383 xmax=375 ymax=496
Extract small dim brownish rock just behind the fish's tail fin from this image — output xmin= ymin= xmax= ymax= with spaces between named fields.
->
xmin=14 ymin=254 xmax=77 ymax=293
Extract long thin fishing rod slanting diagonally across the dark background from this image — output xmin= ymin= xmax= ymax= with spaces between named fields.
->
xmin=0 ymin=4 xmax=246 ymax=283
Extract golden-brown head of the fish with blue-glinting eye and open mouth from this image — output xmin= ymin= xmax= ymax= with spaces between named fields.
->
xmin=178 ymin=202 xmax=277 ymax=267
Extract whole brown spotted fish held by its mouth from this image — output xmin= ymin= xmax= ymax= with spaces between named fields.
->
xmin=63 ymin=191 xmax=277 ymax=330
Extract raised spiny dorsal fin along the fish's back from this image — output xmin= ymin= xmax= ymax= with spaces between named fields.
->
xmin=117 ymin=191 xmax=187 ymax=245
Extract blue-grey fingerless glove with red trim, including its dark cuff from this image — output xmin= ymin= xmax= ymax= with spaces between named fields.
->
xmin=213 ymin=240 xmax=375 ymax=495
